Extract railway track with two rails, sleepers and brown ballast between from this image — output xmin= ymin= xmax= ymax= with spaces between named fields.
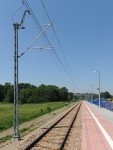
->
xmin=24 ymin=103 xmax=81 ymax=150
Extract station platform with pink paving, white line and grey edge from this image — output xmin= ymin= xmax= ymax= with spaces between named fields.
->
xmin=82 ymin=101 xmax=113 ymax=150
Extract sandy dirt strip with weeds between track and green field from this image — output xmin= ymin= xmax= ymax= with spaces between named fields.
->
xmin=0 ymin=103 xmax=77 ymax=150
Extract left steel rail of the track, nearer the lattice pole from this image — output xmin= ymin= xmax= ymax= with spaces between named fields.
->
xmin=24 ymin=102 xmax=79 ymax=150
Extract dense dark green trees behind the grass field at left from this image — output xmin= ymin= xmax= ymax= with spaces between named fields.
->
xmin=0 ymin=83 xmax=77 ymax=103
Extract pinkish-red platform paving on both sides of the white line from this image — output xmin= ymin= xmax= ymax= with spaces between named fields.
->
xmin=82 ymin=102 xmax=113 ymax=150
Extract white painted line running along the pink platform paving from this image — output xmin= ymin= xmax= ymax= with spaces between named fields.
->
xmin=85 ymin=103 xmax=113 ymax=150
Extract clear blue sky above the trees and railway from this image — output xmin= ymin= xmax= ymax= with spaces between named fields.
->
xmin=0 ymin=0 xmax=113 ymax=94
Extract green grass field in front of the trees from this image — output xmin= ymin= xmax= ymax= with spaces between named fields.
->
xmin=0 ymin=102 xmax=66 ymax=131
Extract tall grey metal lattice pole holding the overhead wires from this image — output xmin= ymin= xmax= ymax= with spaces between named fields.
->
xmin=13 ymin=10 xmax=30 ymax=140
